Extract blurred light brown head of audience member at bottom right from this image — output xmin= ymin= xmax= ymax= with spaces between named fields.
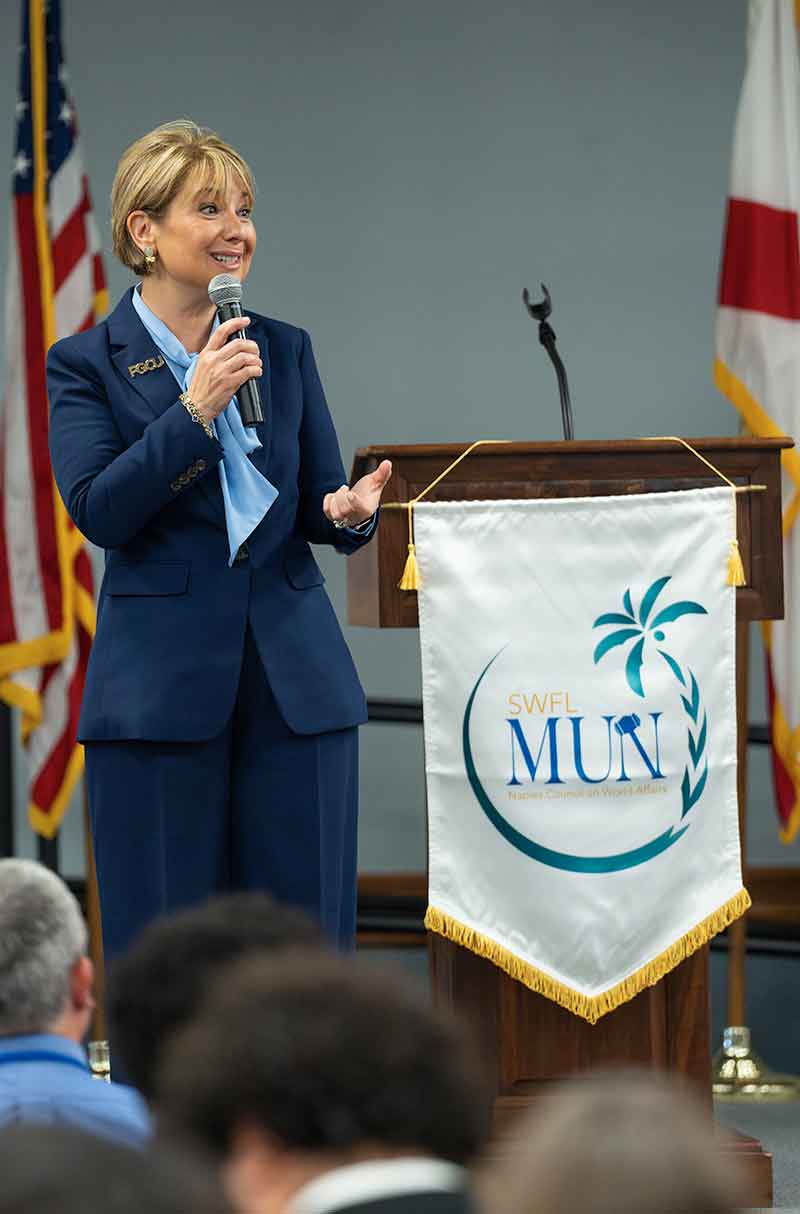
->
xmin=487 ymin=1071 xmax=737 ymax=1214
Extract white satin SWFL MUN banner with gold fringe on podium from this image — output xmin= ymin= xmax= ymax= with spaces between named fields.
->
xmin=414 ymin=488 xmax=749 ymax=1022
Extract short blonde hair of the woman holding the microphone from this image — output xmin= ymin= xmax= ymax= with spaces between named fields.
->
xmin=112 ymin=119 xmax=255 ymax=274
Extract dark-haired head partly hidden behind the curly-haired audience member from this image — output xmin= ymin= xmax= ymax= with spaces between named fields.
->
xmin=107 ymin=894 xmax=322 ymax=1101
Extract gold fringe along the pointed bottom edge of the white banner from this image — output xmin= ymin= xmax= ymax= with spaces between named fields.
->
xmin=425 ymin=887 xmax=750 ymax=1025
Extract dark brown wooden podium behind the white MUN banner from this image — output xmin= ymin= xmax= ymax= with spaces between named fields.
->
xmin=347 ymin=438 xmax=793 ymax=1206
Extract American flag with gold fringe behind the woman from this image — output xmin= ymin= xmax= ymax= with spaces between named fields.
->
xmin=0 ymin=0 xmax=107 ymax=838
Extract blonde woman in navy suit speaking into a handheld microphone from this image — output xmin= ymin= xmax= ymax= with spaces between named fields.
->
xmin=47 ymin=121 xmax=391 ymax=955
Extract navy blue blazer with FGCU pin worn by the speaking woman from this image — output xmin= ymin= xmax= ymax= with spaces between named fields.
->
xmin=47 ymin=291 xmax=367 ymax=742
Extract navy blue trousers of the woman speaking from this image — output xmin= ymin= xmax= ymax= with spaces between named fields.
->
xmin=86 ymin=634 xmax=358 ymax=955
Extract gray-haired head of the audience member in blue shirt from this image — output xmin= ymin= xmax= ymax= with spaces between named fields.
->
xmin=0 ymin=860 xmax=93 ymax=1042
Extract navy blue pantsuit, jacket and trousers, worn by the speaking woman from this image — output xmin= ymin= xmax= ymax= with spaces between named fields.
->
xmin=47 ymin=293 xmax=368 ymax=955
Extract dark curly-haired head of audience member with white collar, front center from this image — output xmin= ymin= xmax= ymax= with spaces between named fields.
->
xmin=159 ymin=954 xmax=489 ymax=1212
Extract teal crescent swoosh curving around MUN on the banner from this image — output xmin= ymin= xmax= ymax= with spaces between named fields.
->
xmin=463 ymin=646 xmax=688 ymax=873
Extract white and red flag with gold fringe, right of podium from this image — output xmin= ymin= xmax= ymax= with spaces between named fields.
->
xmin=714 ymin=0 xmax=800 ymax=843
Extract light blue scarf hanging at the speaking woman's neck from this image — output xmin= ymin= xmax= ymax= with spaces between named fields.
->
xmin=134 ymin=288 xmax=278 ymax=566
